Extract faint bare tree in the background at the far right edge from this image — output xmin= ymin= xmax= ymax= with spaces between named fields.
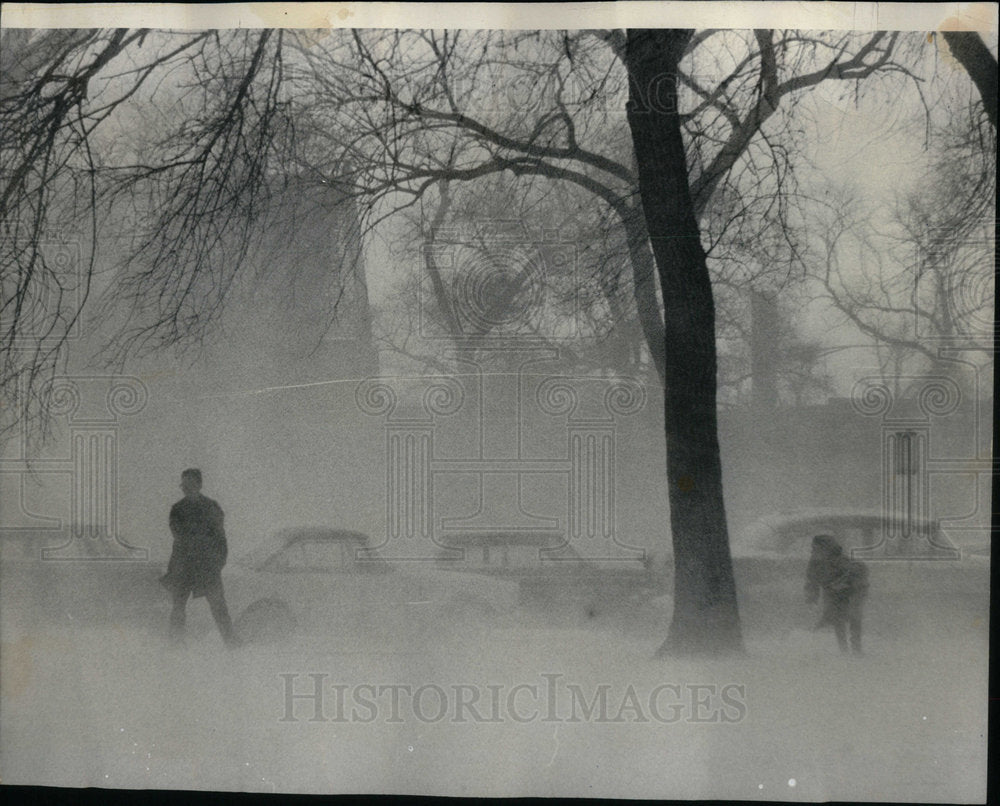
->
xmin=814 ymin=100 xmax=996 ymax=372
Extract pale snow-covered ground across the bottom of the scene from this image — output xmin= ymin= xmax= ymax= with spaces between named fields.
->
xmin=0 ymin=564 xmax=988 ymax=802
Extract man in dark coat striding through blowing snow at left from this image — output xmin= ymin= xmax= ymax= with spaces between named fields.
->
xmin=160 ymin=468 xmax=239 ymax=647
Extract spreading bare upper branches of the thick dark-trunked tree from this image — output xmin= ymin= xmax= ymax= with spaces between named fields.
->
xmin=288 ymin=31 xmax=903 ymax=379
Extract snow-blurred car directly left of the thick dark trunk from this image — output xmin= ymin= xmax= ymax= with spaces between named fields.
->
xmin=436 ymin=531 xmax=671 ymax=619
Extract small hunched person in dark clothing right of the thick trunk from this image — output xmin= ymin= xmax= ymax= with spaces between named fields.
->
xmin=806 ymin=535 xmax=868 ymax=654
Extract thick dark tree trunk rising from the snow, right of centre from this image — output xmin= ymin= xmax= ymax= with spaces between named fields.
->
xmin=626 ymin=29 xmax=743 ymax=654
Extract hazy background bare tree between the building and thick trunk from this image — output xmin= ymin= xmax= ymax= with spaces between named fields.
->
xmin=385 ymin=174 xmax=644 ymax=383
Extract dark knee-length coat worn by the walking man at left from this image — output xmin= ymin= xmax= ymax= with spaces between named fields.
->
xmin=160 ymin=493 xmax=229 ymax=597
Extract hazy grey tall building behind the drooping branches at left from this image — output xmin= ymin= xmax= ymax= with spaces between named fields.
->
xmin=205 ymin=180 xmax=378 ymax=386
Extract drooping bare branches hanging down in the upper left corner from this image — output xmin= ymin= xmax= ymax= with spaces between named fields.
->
xmin=0 ymin=29 xmax=300 ymax=442
